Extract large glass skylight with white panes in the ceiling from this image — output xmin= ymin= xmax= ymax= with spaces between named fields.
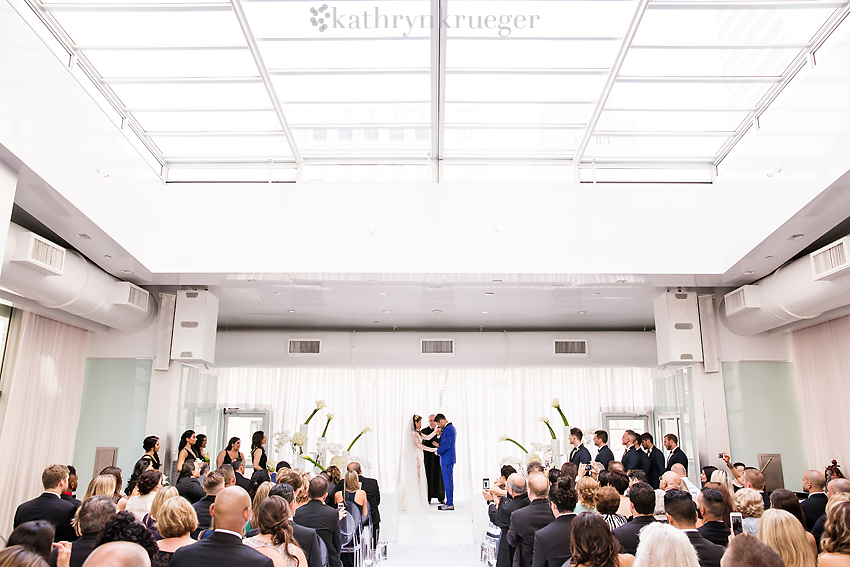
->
xmin=26 ymin=0 xmax=850 ymax=183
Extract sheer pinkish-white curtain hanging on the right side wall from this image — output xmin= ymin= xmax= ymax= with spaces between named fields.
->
xmin=791 ymin=317 xmax=850 ymax=474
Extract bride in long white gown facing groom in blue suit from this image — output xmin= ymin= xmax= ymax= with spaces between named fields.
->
xmin=398 ymin=415 xmax=437 ymax=514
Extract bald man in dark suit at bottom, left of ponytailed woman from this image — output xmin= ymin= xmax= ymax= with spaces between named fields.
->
xmin=170 ymin=486 xmax=274 ymax=567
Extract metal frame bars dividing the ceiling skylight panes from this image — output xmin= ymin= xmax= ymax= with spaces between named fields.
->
xmin=11 ymin=0 xmax=850 ymax=181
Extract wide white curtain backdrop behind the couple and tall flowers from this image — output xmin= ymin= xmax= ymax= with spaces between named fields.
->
xmin=219 ymin=368 xmax=651 ymax=500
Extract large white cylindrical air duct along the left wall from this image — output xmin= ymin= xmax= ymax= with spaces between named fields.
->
xmin=0 ymin=223 xmax=157 ymax=333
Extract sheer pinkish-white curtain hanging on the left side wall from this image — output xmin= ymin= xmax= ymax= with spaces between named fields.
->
xmin=0 ymin=312 xmax=88 ymax=537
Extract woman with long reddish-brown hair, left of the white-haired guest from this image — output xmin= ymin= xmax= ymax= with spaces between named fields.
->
xmin=570 ymin=512 xmax=635 ymax=567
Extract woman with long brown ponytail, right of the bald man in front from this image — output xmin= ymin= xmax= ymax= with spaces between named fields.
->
xmin=242 ymin=496 xmax=307 ymax=567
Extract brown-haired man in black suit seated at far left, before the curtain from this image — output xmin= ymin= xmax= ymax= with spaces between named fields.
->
xmin=14 ymin=465 xmax=77 ymax=541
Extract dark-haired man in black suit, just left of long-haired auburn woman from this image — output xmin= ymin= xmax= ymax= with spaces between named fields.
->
xmin=532 ymin=477 xmax=578 ymax=567
